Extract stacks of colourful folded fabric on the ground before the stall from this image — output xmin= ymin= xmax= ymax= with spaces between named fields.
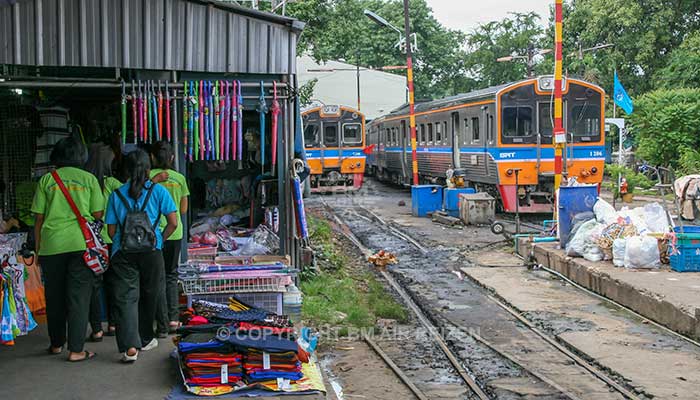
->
xmin=177 ymin=297 xmax=309 ymax=394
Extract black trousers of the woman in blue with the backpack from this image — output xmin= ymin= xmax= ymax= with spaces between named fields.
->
xmin=106 ymin=250 xmax=163 ymax=353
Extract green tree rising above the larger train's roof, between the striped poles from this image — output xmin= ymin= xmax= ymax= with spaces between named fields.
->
xmin=467 ymin=12 xmax=544 ymax=87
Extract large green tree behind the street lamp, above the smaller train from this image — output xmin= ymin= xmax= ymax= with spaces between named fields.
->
xmin=287 ymin=0 xmax=474 ymax=98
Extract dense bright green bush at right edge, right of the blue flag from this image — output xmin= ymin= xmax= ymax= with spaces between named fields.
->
xmin=629 ymin=89 xmax=700 ymax=168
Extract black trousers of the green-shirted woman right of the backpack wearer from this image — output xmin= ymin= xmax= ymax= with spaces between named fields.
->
xmin=157 ymin=240 xmax=182 ymax=332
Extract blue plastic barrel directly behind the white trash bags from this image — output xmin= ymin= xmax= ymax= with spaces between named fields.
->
xmin=558 ymin=185 xmax=598 ymax=249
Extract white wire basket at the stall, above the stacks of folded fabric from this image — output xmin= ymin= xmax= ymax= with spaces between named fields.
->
xmin=180 ymin=275 xmax=289 ymax=295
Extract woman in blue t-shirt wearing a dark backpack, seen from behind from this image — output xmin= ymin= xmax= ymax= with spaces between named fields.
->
xmin=106 ymin=149 xmax=178 ymax=363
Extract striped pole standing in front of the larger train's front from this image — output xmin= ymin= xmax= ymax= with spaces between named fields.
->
xmin=553 ymin=0 xmax=566 ymax=198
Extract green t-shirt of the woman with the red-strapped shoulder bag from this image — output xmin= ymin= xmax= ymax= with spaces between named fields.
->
xmin=32 ymin=167 xmax=105 ymax=256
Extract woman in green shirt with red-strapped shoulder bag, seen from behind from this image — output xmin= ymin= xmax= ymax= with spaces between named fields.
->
xmin=32 ymin=138 xmax=104 ymax=361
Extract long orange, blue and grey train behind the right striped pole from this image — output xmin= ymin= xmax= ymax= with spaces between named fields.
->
xmin=367 ymin=75 xmax=606 ymax=213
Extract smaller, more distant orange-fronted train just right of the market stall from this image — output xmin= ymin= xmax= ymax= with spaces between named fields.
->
xmin=302 ymin=105 xmax=366 ymax=192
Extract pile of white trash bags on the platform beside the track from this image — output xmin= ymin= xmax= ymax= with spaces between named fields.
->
xmin=566 ymin=199 xmax=673 ymax=269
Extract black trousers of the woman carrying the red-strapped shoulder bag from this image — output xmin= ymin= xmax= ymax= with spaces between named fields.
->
xmin=39 ymin=251 xmax=97 ymax=353
